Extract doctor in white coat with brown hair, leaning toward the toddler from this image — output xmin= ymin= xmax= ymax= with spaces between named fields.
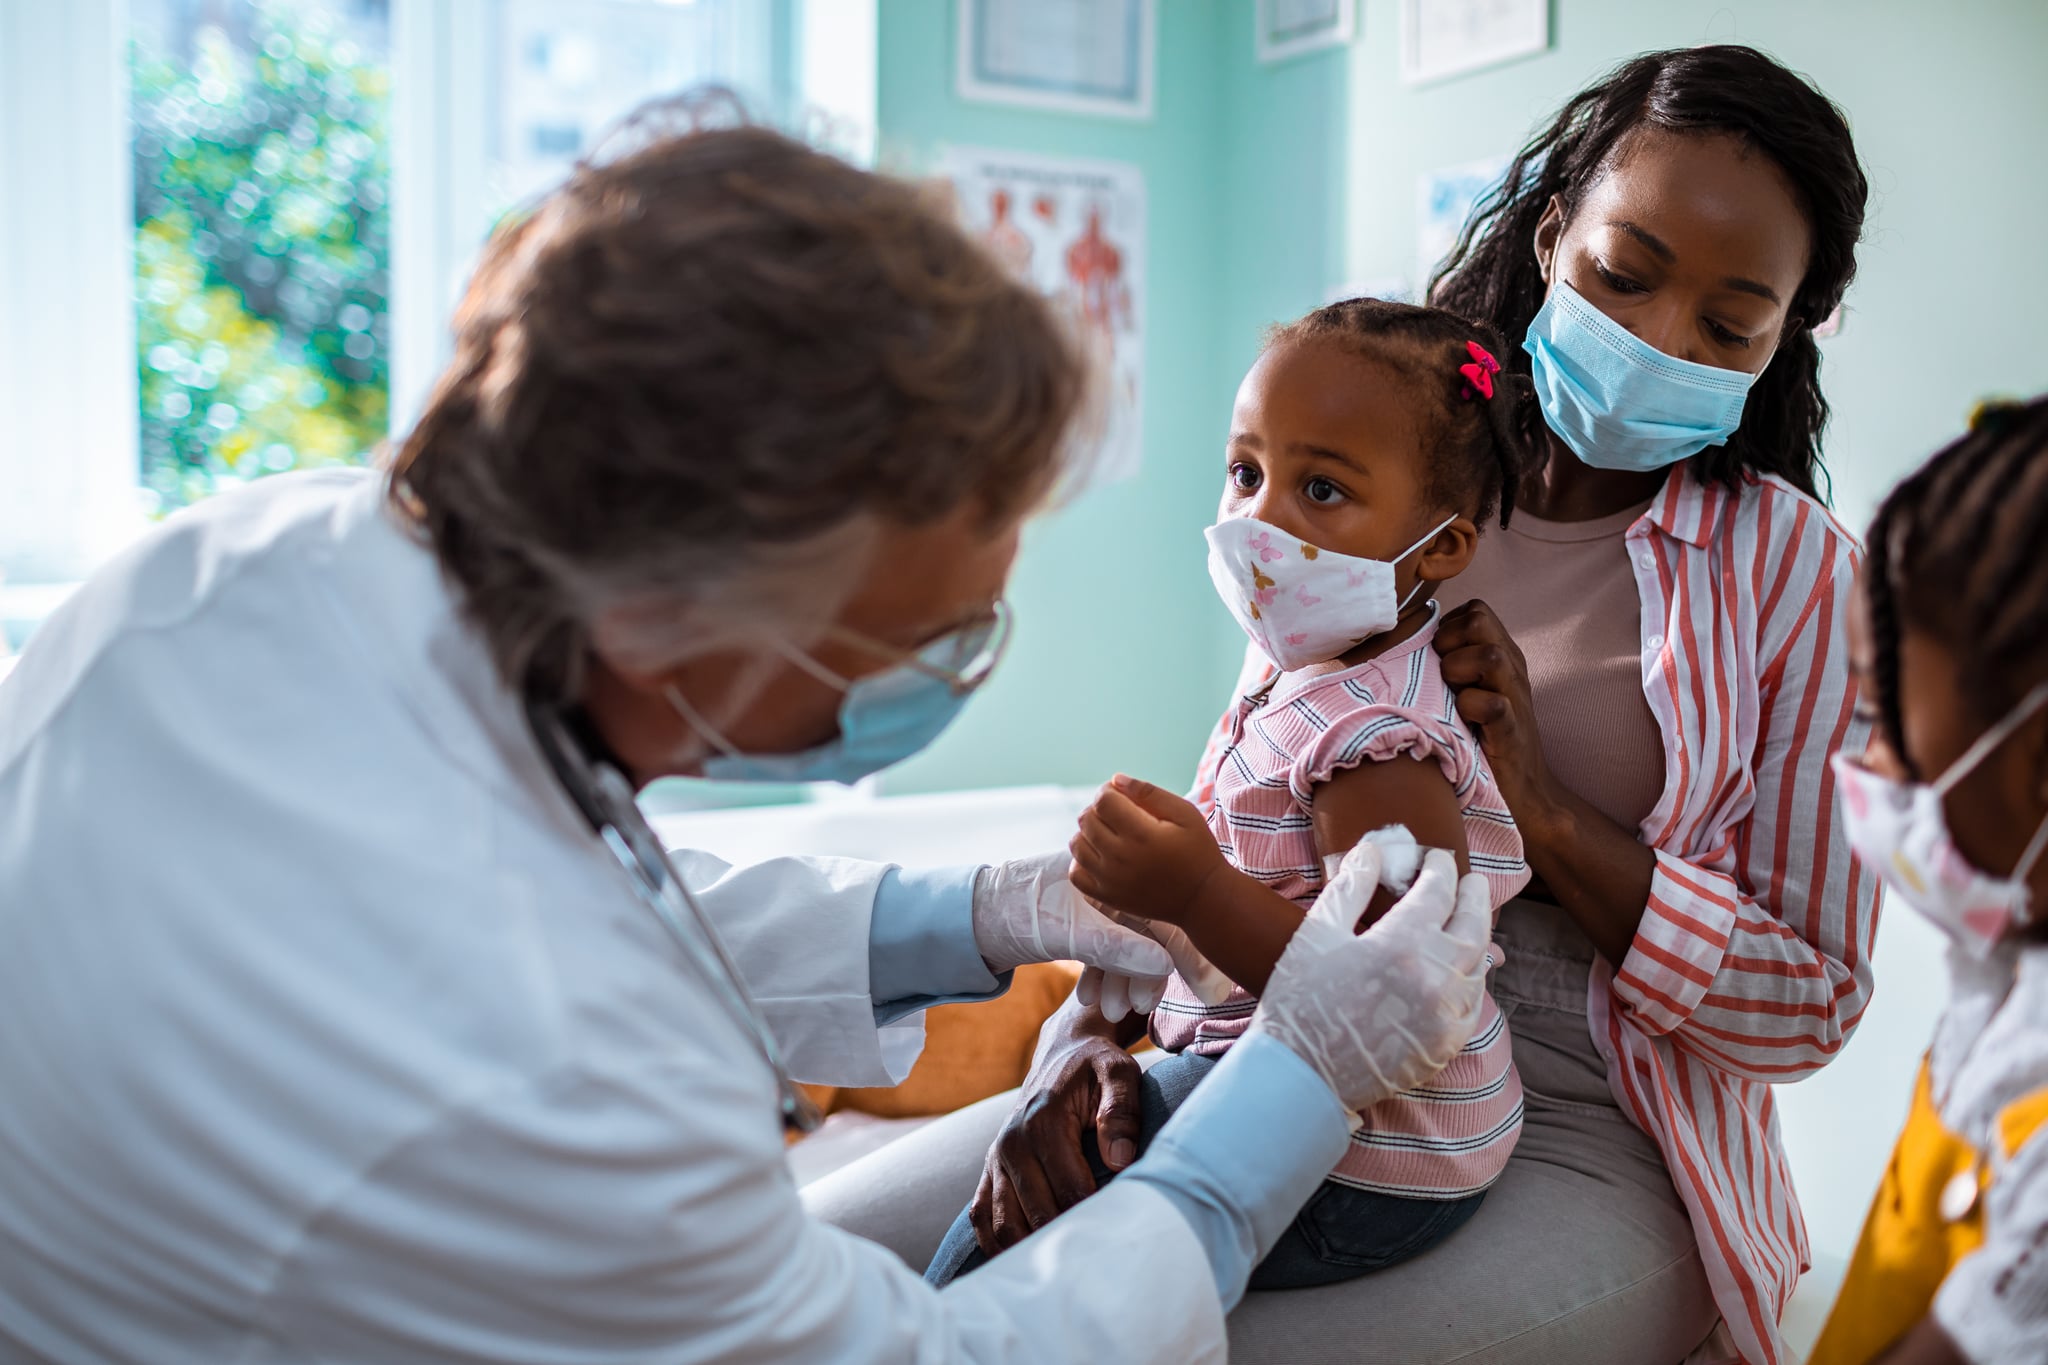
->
xmin=0 ymin=120 xmax=1487 ymax=1363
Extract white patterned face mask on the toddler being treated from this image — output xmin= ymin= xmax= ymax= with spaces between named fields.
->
xmin=1204 ymin=514 xmax=1458 ymax=673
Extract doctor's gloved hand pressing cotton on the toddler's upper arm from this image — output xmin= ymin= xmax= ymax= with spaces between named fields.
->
xmin=1251 ymin=841 xmax=1493 ymax=1113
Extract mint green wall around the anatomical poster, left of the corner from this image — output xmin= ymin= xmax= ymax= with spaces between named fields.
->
xmin=879 ymin=0 xmax=1249 ymax=792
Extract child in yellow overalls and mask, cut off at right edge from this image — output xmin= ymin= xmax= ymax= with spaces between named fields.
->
xmin=1812 ymin=397 xmax=2048 ymax=1365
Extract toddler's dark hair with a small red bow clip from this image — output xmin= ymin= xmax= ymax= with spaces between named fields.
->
xmin=1266 ymin=299 xmax=1536 ymax=526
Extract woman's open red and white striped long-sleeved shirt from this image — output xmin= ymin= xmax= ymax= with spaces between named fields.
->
xmin=1540 ymin=469 xmax=1878 ymax=1365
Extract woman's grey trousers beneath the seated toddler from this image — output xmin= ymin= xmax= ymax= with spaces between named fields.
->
xmin=803 ymin=900 xmax=1718 ymax=1365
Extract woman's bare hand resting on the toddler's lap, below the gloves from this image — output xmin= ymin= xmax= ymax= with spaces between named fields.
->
xmin=969 ymin=1005 xmax=1141 ymax=1257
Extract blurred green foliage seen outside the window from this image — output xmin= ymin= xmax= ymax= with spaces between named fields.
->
xmin=131 ymin=0 xmax=391 ymax=512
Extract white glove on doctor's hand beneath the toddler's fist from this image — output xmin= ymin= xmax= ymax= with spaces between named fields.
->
xmin=975 ymin=849 xmax=1174 ymax=978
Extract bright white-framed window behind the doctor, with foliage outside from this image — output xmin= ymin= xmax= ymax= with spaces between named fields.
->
xmin=0 ymin=0 xmax=874 ymax=657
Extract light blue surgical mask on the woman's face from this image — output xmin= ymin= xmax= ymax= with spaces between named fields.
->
xmin=1522 ymin=280 xmax=1757 ymax=471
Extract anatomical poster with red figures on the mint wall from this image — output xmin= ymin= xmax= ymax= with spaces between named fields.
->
xmin=940 ymin=147 xmax=1145 ymax=483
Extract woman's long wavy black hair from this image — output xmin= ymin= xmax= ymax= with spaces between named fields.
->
xmin=1430 ymin=43 xmax=1870 ymax=509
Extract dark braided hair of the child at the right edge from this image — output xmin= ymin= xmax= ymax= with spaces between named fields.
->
xmin=1866 ymin=397 xmax=2048 ymax=777
